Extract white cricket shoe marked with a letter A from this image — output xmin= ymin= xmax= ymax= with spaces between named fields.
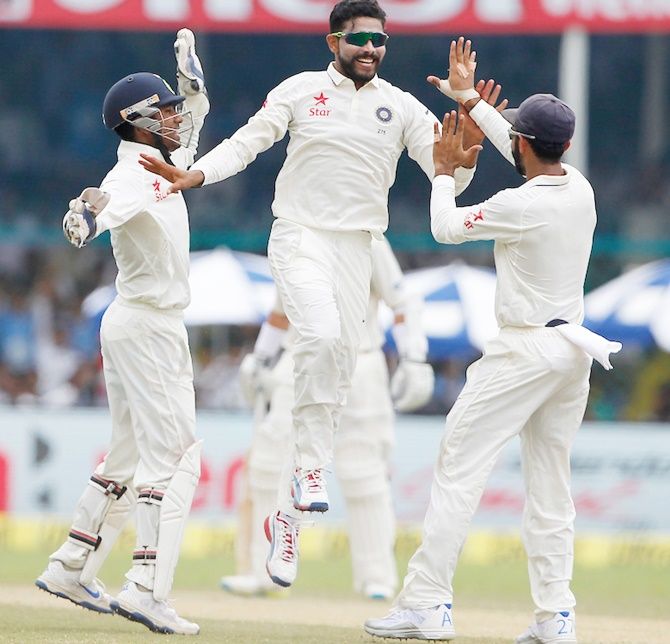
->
xmin=364 ymin=604 xmax=456 ymax=641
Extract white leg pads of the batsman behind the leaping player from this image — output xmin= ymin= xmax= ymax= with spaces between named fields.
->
xmin=252 ymin=349 xmax=398 ymax=591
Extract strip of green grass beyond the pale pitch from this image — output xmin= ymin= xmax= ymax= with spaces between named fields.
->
xmin=0 ymin=550 xmax=670 ymax=620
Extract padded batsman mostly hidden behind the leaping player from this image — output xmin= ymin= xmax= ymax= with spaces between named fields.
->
xmin=221 ymin=238 xmax=434 ymax=599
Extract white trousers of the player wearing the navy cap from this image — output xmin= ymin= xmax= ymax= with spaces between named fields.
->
xmin=396 ymin=327 xmax=591 ymax=620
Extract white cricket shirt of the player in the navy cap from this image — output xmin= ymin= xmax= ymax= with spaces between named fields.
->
xmin=430 ymin=101 xmax=596 ymax=328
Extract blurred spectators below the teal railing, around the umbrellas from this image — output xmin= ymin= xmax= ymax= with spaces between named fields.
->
xmin=0 ymin=243 xmax=670 ymax=422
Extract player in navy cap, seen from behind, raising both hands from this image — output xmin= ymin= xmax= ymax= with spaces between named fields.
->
xmin=365 ymin=40 xmax=620 ymax=644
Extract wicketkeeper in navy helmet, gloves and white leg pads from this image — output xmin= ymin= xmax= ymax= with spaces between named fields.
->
xmin=36 ymin=29 xmax=209 ymax=634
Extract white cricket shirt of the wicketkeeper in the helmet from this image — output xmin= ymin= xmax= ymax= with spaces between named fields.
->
xmin=96 ymin=141 xmax=193 ymax=309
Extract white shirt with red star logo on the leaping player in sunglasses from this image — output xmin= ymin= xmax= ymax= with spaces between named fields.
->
xmin=192 ymin=63 xmax=474 ymax=236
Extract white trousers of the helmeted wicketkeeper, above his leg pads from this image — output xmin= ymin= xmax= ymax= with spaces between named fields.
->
xmin=96 ymin=300 xmax=196 ymax=490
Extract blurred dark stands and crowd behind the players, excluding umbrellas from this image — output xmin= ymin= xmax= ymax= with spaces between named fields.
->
xmin=0 ymin=30 xmax=670 ymax=421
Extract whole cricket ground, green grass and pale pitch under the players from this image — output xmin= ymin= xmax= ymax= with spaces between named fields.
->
xmin=0 ymin=549 xmax=670 ymax=644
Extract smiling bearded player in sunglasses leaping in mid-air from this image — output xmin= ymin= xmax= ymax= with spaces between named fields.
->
xmin=139 ymin=0 xmax=474 ymax=564
